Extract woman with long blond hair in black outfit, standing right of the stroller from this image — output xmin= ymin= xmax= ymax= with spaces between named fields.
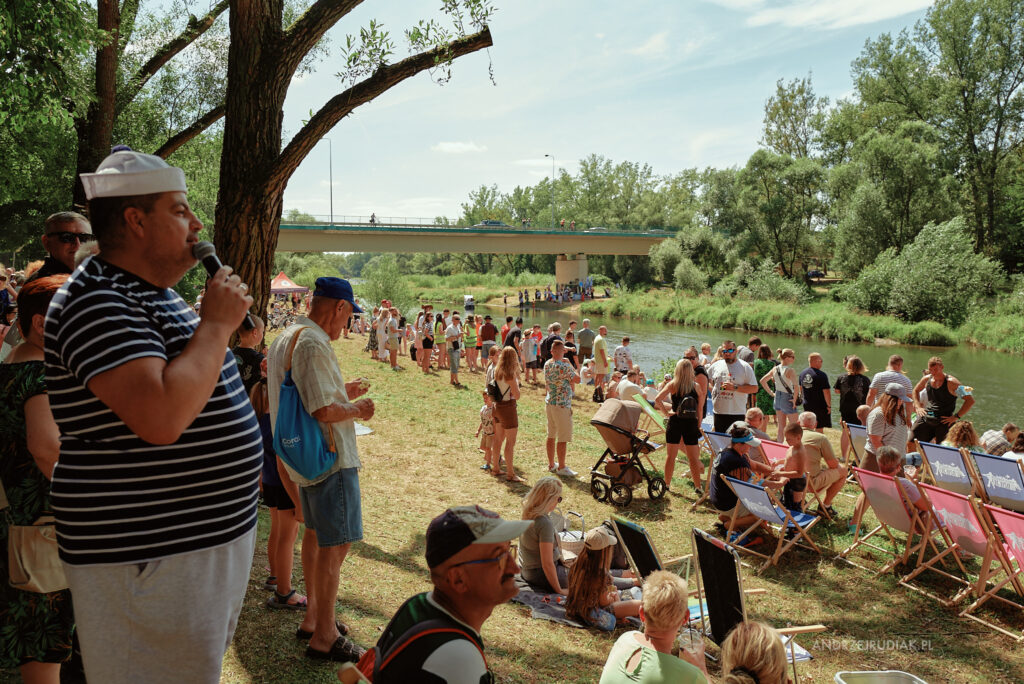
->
xmin=654 ymin=358 xmax=707 ymax=496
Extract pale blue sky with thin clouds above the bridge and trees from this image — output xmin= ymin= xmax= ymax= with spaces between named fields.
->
xmin=276 ymin=0 xmax=931 ymax=218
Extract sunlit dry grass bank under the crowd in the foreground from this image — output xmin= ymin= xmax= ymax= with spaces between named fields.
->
xmin=218 ymin=337 xmax=1024 ymax=683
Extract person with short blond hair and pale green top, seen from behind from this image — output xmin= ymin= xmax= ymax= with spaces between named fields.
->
xmin=600 ymin=570 xmax=708 ymax=684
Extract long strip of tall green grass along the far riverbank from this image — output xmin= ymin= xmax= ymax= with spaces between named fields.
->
xmin=580 ymin=290 xmax=962 ymax=348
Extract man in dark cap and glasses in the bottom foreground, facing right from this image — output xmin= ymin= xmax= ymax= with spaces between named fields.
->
xmin=374 ymin=506 xmax=534 ymax=684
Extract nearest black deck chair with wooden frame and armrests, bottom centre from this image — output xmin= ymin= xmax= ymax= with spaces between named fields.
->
xmin=691 ymin=527 xmax=825 ymax=682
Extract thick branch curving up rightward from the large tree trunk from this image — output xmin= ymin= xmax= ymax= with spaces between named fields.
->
xmin=271 ymin=27 xmax=494 ymax=187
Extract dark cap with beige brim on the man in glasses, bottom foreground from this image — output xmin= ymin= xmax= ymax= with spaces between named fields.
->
xmin=426 ymin=506 xmax=534 ymax=568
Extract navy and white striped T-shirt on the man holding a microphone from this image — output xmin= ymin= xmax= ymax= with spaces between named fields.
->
xmin=45 ymin=257 xmax=263 ymax=565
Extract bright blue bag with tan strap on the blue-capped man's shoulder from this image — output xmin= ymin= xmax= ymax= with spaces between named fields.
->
xmin=273 ymin=328 xmax=338 ymax=480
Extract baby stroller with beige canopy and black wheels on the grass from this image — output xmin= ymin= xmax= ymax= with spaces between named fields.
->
xmin=590 ymin=399 xmax=669 ymax=506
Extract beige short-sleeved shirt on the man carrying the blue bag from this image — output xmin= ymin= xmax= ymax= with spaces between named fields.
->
xmin=266 ymin=316 xmax=362 ymax=486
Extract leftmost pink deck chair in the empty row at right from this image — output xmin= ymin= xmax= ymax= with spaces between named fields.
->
xmin=836 ymin=468 xmax=939 ymax=575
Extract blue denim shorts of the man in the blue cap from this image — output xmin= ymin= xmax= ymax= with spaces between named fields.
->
xmin=299 ymin=468 xmax=362 ymax=549
